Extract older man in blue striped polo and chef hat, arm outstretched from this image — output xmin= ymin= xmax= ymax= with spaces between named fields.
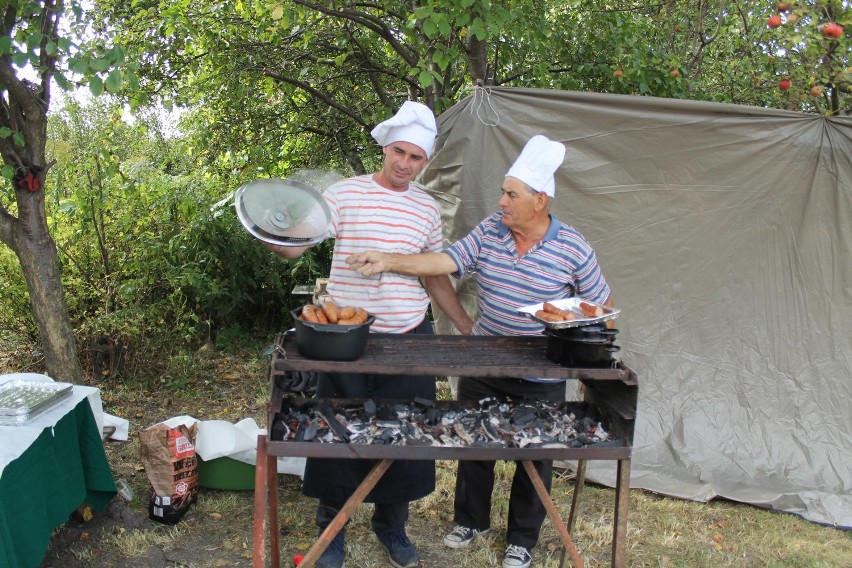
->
xmin=347 ymin=135 xmax=613 ymax=568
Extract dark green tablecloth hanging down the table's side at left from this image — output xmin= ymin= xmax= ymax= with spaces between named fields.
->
xmin=0 ymin=398 xmax=116 ymax=568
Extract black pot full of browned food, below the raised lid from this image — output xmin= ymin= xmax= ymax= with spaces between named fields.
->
xmin=290 ymin=308 xmax=376 ymax=361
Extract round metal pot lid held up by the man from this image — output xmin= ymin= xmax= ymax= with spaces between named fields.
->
xmin=234 ymin=178 xmax=331 ymax=246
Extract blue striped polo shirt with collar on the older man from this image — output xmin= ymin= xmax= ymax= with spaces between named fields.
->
xmin=444 ymin=212 xmax=610 ymax=335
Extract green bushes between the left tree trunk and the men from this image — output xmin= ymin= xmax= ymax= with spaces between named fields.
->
xmin=14 ymin=99 xmax=330 ymax=364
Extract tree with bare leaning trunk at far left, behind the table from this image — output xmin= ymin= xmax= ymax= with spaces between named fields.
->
xmin=0 ymin=0 xmax=125 ymax=381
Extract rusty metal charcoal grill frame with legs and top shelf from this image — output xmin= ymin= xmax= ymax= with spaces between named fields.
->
xmin=253 ymin=332 xmax=638 ymax=568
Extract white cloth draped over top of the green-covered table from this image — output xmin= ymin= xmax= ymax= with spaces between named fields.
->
xmin=0 ymin=373 xmax=104 ymax=477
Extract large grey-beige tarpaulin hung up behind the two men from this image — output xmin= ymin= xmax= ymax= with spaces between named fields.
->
xmin=421 ymin=88 xmax=852 ymax=527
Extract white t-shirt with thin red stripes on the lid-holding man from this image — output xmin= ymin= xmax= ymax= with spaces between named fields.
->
xmin=323 ymin=175 xmax=443 ymax=333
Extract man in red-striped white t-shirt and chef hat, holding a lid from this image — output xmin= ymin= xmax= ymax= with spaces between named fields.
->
xmin=266 ymin=101 xmax=473 ymax=568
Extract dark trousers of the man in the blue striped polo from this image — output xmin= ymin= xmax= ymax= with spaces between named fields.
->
xmin=454 ymin=377 xmax=565 ymax=548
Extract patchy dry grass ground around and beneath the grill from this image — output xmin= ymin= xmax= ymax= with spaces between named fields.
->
xmin=0 ymin=336 xmax=852 ymax=568
